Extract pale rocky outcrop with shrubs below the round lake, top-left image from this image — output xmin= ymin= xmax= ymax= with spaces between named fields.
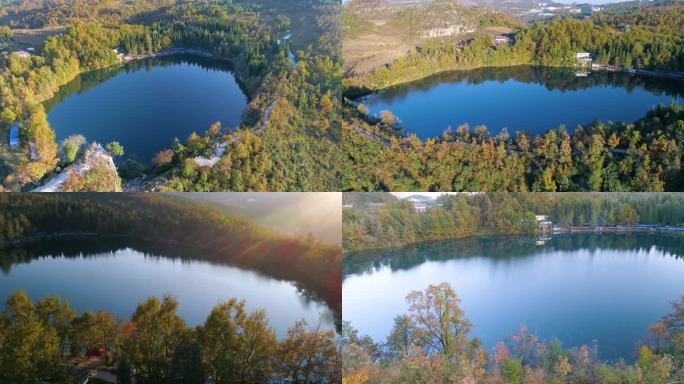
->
xmin=32 ymin=143 xmax=121 ymax=192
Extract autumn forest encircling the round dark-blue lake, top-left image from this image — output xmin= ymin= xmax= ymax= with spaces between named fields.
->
xmin=0 ymin=0 xmax=341 ymax=191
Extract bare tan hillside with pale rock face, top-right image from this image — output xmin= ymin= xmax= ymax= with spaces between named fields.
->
xmin=341 ymin=0 xmax=520 ymax=75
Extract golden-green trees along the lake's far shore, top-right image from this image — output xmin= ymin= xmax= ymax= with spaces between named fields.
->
xmin=346 ymin=2 xmax=684 ymax=90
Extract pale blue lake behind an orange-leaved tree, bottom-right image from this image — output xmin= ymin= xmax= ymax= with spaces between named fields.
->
xmin=342 ymin=234 xmax=684 ymax=361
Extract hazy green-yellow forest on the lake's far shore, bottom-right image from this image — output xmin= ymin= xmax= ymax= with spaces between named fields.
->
xmin=342 ymin=193 xmax=684 ymax=251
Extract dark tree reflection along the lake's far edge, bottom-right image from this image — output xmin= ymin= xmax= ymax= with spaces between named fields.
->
xmin=342 ymin=233 xmax=684 ymax=278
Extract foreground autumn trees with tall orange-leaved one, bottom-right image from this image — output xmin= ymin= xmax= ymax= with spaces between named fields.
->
xmin=342 ymin=283 xmax=684 ymax=384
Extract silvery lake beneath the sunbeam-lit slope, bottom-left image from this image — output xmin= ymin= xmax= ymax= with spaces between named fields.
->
xmin=0 ymin=236 xmax=335 ymax=337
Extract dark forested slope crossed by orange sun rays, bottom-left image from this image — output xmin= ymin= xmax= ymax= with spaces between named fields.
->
xmin=0 ymin=194 xmax=342 ymax=313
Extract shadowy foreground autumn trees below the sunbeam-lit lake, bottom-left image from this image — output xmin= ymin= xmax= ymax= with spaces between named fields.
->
xmin=0 ymin=291 xmax=341 ymax=384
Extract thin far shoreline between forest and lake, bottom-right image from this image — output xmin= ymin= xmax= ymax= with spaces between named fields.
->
xmin=342 ymin=224 xmax=684 ymax=258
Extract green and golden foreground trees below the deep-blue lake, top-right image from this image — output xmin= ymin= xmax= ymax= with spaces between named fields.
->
xmin=343 ymin=104 xmax=684 ymax=192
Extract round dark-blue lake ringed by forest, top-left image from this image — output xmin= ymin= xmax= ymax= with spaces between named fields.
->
xmin=45 ymin=55 xmax=247 ymax=162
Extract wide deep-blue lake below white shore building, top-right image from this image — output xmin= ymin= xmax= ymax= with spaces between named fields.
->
xmin=358 ymin=66 xmax=684 ymax=139
